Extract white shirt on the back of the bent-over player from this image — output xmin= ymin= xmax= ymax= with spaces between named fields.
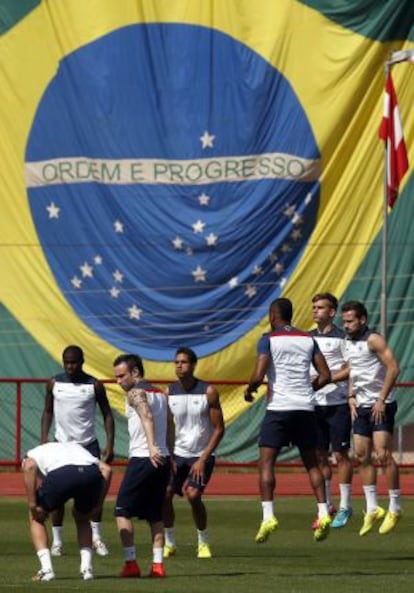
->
xmin=26 ymin=443 xmax=99 ymax=476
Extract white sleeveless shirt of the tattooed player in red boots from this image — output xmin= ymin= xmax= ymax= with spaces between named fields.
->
xmin=125 ymin=381 xmax=170 ymax=457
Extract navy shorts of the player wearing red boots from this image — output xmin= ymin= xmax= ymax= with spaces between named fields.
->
xmin=114 ymin=457 xmax=171 ymax=523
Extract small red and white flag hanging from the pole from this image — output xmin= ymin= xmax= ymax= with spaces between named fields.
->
xmin=379 ymin=71 xmax=408 ymax=208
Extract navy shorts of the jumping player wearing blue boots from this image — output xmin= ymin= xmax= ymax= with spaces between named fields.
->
xmin=315 ymin=404 xmax=352 ymax=452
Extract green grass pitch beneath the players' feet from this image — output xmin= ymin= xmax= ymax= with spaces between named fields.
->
xmin=0 ymin=497 xmax=414 ymax=593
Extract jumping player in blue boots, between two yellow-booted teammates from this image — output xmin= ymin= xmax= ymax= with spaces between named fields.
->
xmin=311 ymin=292 xmax=353 ymax=528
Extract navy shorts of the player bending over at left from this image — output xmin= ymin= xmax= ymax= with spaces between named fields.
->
xmin=36 ymin=465 xmax=104 ymax=514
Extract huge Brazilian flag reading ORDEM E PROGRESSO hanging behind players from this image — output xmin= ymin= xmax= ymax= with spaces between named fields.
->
xmin=0 ymin=0 xmax=414 ymax=461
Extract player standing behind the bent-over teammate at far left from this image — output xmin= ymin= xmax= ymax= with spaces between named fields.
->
xmin=41 ymin=345 xmax=115 ymax=556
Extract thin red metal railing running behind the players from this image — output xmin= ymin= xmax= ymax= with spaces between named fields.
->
xmin=0 ymin=377 xmax=414 ymax=469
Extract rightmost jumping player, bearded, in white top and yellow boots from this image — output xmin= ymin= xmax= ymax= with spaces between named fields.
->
xmin=342 ymin=301 xmax=402 ymax=536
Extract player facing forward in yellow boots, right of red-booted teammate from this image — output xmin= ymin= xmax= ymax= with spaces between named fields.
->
xmin=163 ymin=347 xmax=224 ymax=558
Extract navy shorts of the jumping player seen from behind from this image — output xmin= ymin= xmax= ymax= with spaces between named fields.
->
xmin=259 ymin=410 xmax=317 ymax=451
